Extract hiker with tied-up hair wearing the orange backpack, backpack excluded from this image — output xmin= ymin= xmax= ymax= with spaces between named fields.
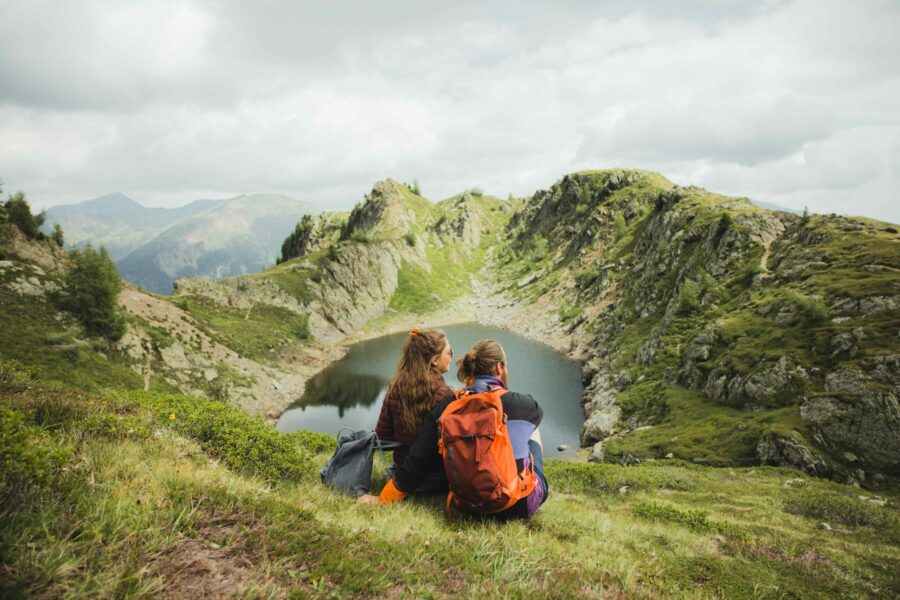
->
xmin=360 ymin=340 xmax=549 ymax=518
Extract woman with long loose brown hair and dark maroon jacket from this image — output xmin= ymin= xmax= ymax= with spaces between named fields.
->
xmin=375 ymin=327 xmax=453 ymax=491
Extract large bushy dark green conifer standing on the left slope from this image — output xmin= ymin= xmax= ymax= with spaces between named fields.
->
xmin=59 ymin=244 xmax=125 ymax=340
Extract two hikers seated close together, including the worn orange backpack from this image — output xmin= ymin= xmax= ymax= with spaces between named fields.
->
xmin=360 ymin=328 xmax=548 ymax=517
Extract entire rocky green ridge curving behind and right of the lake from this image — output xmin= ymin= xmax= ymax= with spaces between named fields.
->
xmin=163 ymin=170 xmax=900 ymax=486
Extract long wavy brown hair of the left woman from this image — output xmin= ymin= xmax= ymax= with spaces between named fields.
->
xmin=387 ymin=327 xmax=447 ymax=431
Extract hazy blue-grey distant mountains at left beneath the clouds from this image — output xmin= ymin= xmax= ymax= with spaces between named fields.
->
xmin=45 ymin=193 xmax=319 ymax=294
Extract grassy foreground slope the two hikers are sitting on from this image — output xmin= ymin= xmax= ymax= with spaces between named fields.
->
xmin=0 ymin=365 xmax=900 ymax=598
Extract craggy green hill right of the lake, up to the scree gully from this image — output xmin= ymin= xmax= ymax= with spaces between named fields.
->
xmin=494 ymin=170 xmax=900 ymax=485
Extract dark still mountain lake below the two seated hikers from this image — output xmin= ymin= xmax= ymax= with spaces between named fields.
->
xmin=278 ymin=323 xmax=584 ymax=458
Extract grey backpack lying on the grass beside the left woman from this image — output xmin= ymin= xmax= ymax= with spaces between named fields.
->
xmin=319 ymin=428 xmax=400 ymax=496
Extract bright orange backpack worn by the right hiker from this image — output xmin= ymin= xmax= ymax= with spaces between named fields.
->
xmin=438 ymin=388 xmax=536 ymax=514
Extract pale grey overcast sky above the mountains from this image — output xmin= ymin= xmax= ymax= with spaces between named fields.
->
xmin=0 ymin=0 xmax=900 ymax=222
